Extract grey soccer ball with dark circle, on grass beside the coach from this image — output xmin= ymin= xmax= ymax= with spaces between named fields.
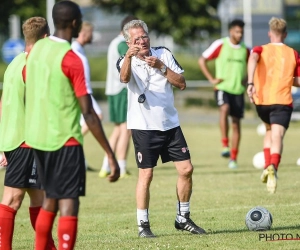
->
xmin=245 ymin=207 xmax=273 ymax=231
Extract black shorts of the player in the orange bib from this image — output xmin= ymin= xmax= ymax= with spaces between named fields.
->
xmin=256 ymin=104 xmax=293 ymax=129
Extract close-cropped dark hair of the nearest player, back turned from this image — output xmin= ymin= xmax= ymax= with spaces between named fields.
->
xmin=52 ymin=0 xmax=81 ymax=29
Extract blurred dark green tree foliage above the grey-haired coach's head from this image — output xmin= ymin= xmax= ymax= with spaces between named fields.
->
xmin=93 ymin=0 xmax=220 ymax=44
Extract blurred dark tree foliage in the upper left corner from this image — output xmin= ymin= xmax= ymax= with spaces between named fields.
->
xmin=0 ymin=0 xmax=50 ymax=38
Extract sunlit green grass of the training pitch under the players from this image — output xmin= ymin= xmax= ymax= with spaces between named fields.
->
xmin=0 ymin=120 xmax=300 ymax=250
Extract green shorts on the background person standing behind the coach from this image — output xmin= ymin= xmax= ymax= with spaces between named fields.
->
xmin=107 ymin=88 xmax=127 ymax=123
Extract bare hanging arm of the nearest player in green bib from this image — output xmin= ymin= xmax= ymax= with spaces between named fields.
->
xmin=78 ymin=95 xmax=120 ymax=182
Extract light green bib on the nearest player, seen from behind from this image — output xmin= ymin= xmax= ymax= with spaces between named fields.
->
xmin=25 ymin=38 xmax=83 ymax=151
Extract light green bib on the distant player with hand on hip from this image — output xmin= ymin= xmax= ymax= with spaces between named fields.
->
xmin=216 ymin=38 xmax=247 ymax=95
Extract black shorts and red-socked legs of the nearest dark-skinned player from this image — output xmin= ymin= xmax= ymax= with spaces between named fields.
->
xmin=34 ymin=146 xmax=85 ymax=250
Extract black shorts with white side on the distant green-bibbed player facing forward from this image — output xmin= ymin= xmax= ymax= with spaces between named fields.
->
xmin=215 ymin=90 xmax=245 ymax=119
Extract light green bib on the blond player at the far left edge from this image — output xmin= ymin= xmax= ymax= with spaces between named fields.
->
xmin=0 ymin=53 xmax=26 ymax=151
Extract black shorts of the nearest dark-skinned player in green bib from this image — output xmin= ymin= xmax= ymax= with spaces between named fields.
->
xmin=33 ymin=145 xmax=85 ymax=199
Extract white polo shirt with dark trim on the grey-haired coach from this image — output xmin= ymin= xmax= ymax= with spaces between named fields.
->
xmin=117 ymin=47 xmax=184 ymax=131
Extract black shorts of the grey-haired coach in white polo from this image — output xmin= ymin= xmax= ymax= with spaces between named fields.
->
xmin=131 ymin=127 xmax=190 ymax=168
